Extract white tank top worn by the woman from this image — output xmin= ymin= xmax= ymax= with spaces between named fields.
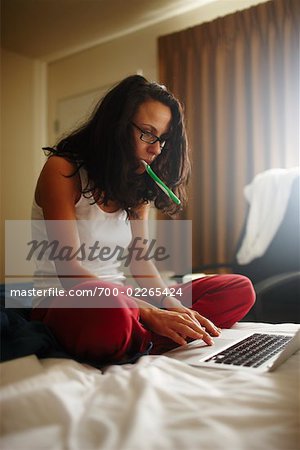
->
xmin=31 ymin=169 xmax=132 ymax=306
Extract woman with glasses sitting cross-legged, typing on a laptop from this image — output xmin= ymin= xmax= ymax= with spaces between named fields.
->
xmin=32 ymin=75 xmax=254 ymax=363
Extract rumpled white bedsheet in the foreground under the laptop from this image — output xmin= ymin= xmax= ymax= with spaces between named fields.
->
xmin=1 ymin=323 xmax=300 ymax=450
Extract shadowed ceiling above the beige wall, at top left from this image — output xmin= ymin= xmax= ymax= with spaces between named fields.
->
xmin=1 ymin=0 xmax=215 ymax=61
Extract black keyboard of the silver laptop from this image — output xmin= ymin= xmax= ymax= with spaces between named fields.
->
xmin=206 ymin=333 xmax=292 ymax=367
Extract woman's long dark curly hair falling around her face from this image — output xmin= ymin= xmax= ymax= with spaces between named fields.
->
xmin=46 ymin=75 xmax=190 ymax=215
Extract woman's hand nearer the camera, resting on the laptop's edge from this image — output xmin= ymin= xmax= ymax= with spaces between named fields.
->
xmin=140 ymin=308 xmax=213 ymax=345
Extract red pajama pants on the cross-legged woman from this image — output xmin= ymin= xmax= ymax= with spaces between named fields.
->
xmin=31 ymin=275 xmax=255 ymax=362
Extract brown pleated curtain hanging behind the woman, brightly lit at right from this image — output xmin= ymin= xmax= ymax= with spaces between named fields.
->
xmin=158 ymin=0 xmax=300 ymax=267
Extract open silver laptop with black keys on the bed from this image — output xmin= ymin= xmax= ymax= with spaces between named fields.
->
xmin=164 ymin=329 xmax=300 ymax=372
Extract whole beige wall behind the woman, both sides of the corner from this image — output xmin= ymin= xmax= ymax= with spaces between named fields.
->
xmin=0 ymin=0 xmax=266 ymax=280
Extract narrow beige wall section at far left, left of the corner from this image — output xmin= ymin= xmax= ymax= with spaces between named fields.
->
xmin=1 ymin=50 xmax=46 ymax=280
